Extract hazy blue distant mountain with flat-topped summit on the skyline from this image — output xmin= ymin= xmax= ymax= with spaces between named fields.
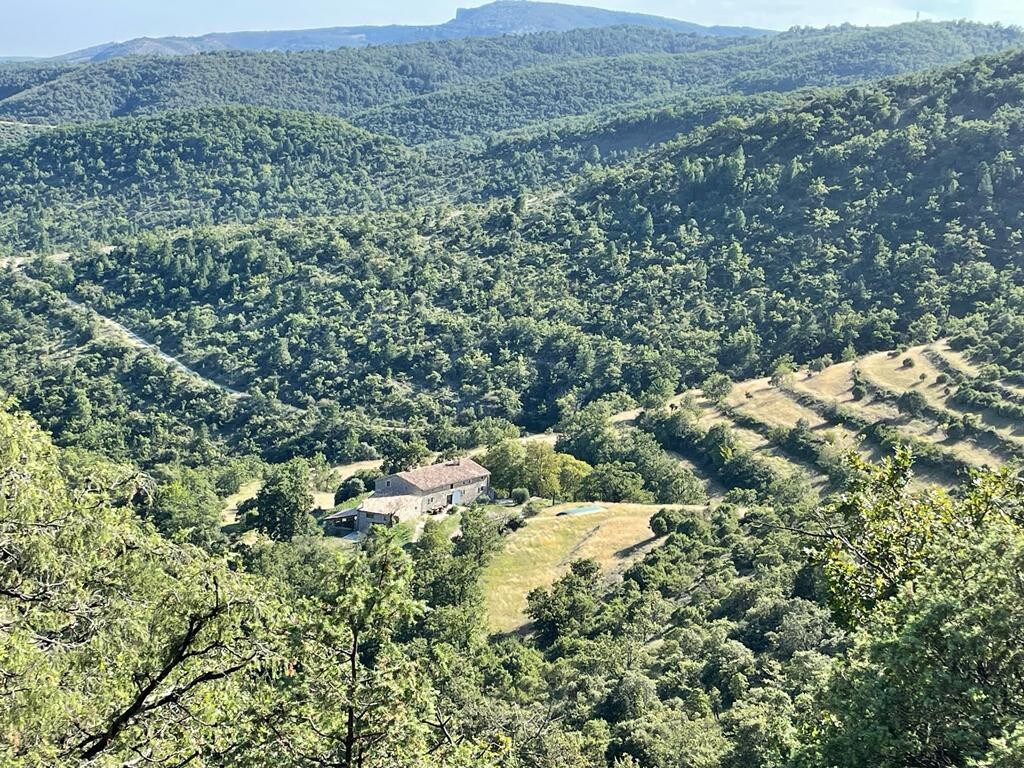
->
xmin=58 ymin=0 xmax=769 ymax=62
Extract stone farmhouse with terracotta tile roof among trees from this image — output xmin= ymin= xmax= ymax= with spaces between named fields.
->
xmin=327 ymin=459 xmax=494 ymax=531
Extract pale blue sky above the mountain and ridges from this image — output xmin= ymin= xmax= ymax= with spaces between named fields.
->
xmin=0 ymin=0 xmax=1024 ymax=56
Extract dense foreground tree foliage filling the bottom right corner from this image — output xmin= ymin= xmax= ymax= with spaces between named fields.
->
xmin=803 ymin=474 xmax=1024 ymax=766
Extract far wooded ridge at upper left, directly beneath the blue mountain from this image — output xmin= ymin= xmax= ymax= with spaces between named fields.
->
xmin=0 ymin=27 xmax=731 ymax=123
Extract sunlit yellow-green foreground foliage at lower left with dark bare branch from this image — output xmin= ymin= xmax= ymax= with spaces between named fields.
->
xmin=0 ymin=403 xmax=289 ymax=766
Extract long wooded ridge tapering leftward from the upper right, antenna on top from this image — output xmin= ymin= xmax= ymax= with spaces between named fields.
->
xmin=351 ymin=23 xmax=1024 ymax=143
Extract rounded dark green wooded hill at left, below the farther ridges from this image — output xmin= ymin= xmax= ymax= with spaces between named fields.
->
xmin=0 ymin=106 xmax=420 ymax=242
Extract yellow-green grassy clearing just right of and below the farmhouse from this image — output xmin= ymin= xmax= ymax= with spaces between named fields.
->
xmin=483 ymin=504 xmax=702 ymax=632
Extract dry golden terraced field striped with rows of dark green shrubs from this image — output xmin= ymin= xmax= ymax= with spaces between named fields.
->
xmin=647 ymin=341 xmax=1024 ymax=496
